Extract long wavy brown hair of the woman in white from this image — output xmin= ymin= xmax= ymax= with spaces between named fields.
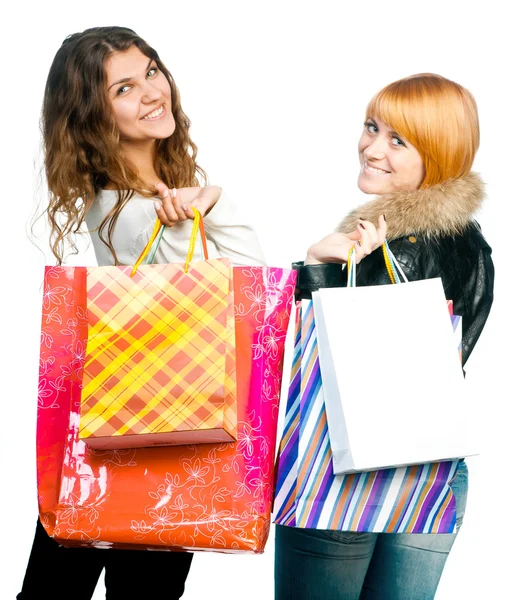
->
xmin=42 ymin=27 xmax=207 ymax=264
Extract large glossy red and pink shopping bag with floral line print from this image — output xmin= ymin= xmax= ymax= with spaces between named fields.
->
xmin=37 ymin=255 xmax=296 ymax=552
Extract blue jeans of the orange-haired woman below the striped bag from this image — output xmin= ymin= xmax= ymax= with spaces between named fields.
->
xmin=275 ymin=462 xmax=468 ymax=600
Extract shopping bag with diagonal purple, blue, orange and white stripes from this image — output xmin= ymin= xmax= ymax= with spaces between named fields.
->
xmin=274 ymin=300 xmax=458 ymax=533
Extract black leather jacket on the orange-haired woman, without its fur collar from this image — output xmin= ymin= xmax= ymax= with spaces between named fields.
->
xmin=293 ymin=221 xmax=494 ymax=365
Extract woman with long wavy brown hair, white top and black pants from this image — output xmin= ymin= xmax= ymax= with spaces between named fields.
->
xmin=18 ymin=27 xmax=264 ymax=600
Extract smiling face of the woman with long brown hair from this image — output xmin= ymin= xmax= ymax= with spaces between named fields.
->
xmin=106 ymin=46 xmax=176 ymax=144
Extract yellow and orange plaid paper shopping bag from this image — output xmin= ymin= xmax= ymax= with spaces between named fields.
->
xmin=80 ymin=259 xmax=237 ymax=448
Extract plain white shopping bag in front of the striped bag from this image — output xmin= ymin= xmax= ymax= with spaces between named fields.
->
xmin=312 ymin=247 xmax=477 ymax=474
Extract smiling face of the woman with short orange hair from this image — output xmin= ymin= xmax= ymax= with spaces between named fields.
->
xmin=357 ymin=117 xmax=425 ymax=195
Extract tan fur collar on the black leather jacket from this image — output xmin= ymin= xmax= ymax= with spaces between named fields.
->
xmin=337 ymin=172 xmax=485 ymax=240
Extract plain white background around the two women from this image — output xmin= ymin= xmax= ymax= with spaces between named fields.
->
xmin=0 ymin=0 xmax=512 ymax=600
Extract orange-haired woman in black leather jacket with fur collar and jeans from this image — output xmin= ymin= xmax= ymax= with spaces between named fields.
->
xmin=275 ymin=74 xmax=494 ymax=600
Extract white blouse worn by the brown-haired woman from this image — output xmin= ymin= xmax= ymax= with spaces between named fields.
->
xmin=85 ymin=190 xmax=266 ymax=266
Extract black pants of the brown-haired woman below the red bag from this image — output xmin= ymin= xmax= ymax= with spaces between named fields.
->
xmin=16 ymin=520 xmax=193 ymax=600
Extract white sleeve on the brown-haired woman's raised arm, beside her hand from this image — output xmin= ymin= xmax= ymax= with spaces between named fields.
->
xmin=204 ymin=192 xmax=266 ymax=266
